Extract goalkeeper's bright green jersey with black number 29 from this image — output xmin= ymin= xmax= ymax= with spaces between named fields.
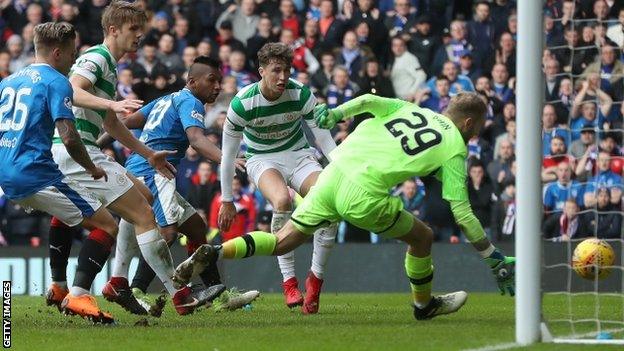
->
xmin=330 ymin=95 xmax=468 ymax=201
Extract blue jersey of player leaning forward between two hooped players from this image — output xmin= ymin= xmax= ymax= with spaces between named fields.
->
xmin=126 ymin=88 xmax=206 ymax=176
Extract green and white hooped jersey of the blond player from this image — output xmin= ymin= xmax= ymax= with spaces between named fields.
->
xmin=54 ymin=44 xmax=117 ymax=146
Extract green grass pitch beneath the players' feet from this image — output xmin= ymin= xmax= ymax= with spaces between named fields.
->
xmin=12 ymin=293 xmax=622 ymax=351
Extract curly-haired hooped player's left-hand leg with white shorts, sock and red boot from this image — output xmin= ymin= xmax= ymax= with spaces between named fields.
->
xmin=252 ymin=160 xmax=303 ymax=308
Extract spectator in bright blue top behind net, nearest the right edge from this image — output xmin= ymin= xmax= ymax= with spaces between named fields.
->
xmin=583 ymin=151 xmax=622 ymax=207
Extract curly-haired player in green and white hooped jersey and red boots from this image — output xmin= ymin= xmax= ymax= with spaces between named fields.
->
xmin=219 ymin=43 xmax=337 ymax=313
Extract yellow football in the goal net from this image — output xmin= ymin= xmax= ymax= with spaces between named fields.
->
xmin=572 ymin=238 xmax=615 ymax=280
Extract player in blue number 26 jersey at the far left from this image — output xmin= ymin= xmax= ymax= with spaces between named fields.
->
xmin=0 ymin=22 xmax=117 ymax=321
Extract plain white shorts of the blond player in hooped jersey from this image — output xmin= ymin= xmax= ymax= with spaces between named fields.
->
xmin=52 ymin=144 xmax=134 ymax=206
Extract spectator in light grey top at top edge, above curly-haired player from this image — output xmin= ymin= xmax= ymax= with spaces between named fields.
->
xmin=217 ymin=0 xmax=260 ymax=43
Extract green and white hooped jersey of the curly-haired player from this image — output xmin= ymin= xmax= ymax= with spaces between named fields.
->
xmin=225 ymin=79 xmax=316 ymax=158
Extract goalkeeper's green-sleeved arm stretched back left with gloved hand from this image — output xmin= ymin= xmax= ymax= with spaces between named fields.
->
xmin=314 ymin=94 xmax=408 ymax=129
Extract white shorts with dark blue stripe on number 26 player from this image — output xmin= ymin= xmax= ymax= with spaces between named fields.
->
xmin=13 ymin=177 xmax=102 ymax=227
